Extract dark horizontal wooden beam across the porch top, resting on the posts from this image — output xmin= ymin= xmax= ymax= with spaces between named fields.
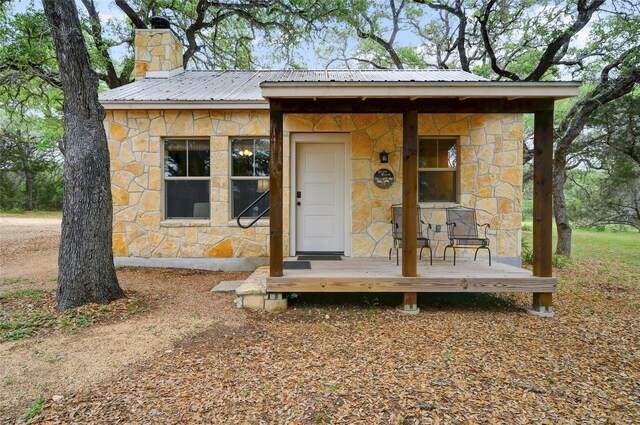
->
xmin=270 ymin=97 xmax=554 ymax=114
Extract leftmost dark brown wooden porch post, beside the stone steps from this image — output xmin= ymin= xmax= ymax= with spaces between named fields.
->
xmin=269 ymin=106 xmax=283 ymax=277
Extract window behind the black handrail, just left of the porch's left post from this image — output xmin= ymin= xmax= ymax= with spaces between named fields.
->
xmin=231 ymin=139 xmax=269 ymax=218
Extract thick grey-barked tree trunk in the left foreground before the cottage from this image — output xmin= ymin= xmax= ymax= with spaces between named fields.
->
xmin=43 ymin=0 xmax=124 ymax=310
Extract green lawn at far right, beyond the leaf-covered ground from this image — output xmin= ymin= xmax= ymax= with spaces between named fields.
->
xmin=522 ymin=222 xmax=640 ymax=266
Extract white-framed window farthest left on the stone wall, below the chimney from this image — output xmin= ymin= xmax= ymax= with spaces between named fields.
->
xmin=164 ymin=139 xmax=211 ymax=219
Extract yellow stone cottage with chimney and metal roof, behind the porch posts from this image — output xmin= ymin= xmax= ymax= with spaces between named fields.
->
xmin=100 ymin=25 xmax=577 ymax=312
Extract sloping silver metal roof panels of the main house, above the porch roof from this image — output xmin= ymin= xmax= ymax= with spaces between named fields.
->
xmin=100 ymin=70 xmax=487 ymax=102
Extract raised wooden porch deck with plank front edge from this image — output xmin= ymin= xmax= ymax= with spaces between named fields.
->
xmin=266 ymin=258 xmax=557 ymax=293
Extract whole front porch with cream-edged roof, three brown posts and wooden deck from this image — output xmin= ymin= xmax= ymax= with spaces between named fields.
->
xmin=260 ymin=80 xmax=577 ymax=316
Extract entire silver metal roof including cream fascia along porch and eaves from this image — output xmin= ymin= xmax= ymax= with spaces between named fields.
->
xmin=100 ymin=69 xmax=579 ymax=109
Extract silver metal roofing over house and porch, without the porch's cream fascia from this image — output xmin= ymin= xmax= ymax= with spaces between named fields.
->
xmin=100 ymin=69 xmax=578 ymax=109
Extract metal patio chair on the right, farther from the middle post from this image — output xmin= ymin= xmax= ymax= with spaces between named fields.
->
xmin=444 ymin=207 xmax=491 ymax=266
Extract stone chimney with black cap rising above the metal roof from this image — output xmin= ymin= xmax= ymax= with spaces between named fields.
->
xmin=135 ymin=17 xmax=184 ymax=80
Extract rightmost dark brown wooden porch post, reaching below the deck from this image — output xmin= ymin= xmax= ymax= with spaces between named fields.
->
xmin=533 ymin=104 xmax=553 ymax=314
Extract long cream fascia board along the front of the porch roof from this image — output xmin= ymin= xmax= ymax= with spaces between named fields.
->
xmin=261 ymin=83 xmax=579 ymax=99
